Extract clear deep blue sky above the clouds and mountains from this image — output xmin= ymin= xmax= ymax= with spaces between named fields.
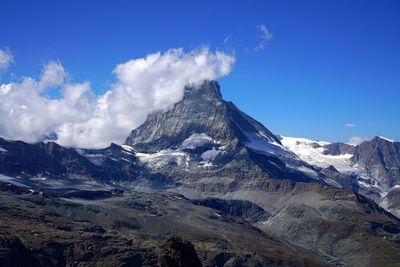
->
xmin=0 ymin=0 xmax=400 ymax=141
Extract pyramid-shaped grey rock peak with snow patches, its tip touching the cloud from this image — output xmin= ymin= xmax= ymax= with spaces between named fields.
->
xmin=125 ymin=81 xmax=338 ymax=188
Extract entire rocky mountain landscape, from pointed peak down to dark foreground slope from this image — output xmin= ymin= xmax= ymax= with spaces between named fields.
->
xmin=0 ymin=81 xmax=400 ymax=267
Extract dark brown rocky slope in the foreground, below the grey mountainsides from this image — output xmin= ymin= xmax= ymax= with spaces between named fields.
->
xmin=0 ymin=183 xmax=326 ymax=267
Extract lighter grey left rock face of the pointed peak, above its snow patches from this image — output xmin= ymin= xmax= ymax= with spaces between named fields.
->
xmin=125 ymin=81 xmax=234 ymax=151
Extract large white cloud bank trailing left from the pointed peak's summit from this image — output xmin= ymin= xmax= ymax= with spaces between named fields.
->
xmin=0 ymin=48 xmax=235 ymax=147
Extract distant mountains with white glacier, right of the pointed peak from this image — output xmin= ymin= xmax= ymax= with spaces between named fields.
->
xmin=280 ymin=136 xmax=400 ymax=216
